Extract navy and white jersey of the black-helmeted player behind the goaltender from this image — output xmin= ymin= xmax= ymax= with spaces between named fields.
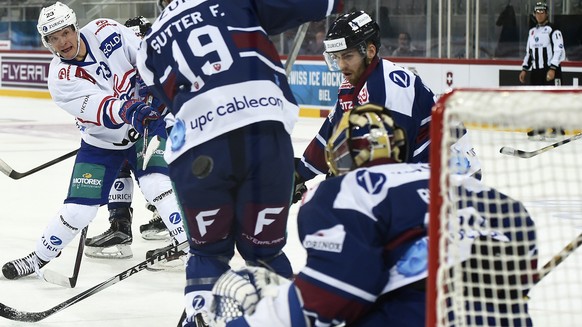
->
xmin=296 ymin=58 xmax=435 ymax=180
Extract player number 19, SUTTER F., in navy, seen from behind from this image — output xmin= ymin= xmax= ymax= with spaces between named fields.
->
xmin=138 ymin=0 xmax=342 ymax=326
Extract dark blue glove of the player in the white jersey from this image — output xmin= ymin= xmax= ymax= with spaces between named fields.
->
xmin=119 ymin=100 xmax=164 ymax=135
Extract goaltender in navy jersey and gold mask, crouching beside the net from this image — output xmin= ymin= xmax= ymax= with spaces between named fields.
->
xmin=213 ymin=104 xmax=537 ymax=327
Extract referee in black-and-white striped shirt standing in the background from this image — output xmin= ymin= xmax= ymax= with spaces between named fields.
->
xmin=519 ymin=2 xmax=566 ymax=141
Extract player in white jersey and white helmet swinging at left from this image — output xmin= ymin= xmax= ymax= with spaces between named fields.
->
xmin=2 ymin=2 xmax=186 ymax=279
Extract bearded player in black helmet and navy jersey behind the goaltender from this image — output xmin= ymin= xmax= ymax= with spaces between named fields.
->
xmin=293 ymin=11 xmax=480 ymax=202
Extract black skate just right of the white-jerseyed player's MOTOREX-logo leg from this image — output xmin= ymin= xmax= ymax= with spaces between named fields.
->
xmin=85 ymin=208 xmax=133 ymax=259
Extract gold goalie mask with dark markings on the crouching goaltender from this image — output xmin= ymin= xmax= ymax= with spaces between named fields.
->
xmin=325 ymin=103 xmax=408 ymax=176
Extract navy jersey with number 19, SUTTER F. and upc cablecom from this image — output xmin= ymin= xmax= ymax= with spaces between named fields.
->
xmin=138 ymin=0 xmax=342 ymax=163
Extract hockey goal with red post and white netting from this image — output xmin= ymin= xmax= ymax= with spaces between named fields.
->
xmin=427 ymin=87 xmax=582 ymax=327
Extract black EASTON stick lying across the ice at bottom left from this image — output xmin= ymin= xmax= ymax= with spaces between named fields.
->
xmin=0 ymin=242 xmax=188 ymax=322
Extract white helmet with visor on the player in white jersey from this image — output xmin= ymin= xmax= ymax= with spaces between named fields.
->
xmin=36 ymin=2 xmax=81 ymax=60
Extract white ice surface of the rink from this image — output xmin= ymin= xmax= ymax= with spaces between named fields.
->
xmin=0 ymin=97 xmax=582 ymax=327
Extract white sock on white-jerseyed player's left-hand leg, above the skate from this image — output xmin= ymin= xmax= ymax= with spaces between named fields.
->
xmin=36 ymin=203 xmax=98 ymax=261
